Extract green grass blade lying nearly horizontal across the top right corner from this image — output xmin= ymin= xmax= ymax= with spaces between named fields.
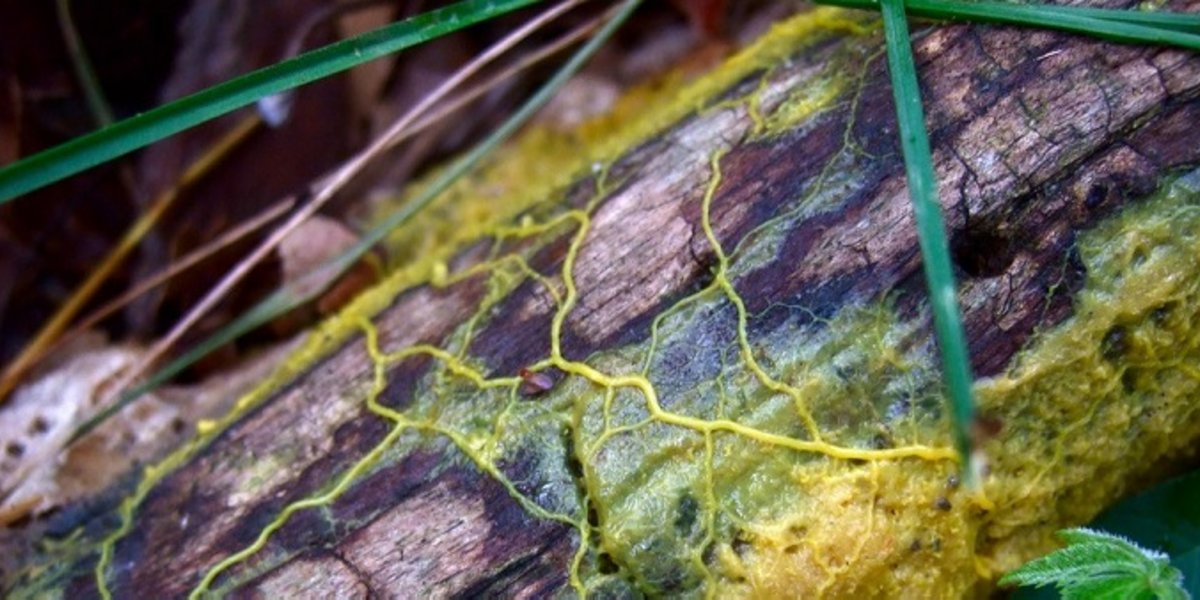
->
xmin=816 ymin=0 xmax=1200 ymax=50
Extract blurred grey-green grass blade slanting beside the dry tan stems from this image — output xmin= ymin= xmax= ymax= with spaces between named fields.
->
xmin=71 ymin=0 xmax=641 ymax=442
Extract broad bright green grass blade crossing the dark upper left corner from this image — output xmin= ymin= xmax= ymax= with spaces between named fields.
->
xmin=0 ymin=0 xmax=538 ymax=204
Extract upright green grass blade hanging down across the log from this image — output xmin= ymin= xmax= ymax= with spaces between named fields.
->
xmin=881 ymin=0 xmax=976 ymax=476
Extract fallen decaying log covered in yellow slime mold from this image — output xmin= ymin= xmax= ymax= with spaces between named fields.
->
xmin=7 ymin=4 xmax=1200 ymax=598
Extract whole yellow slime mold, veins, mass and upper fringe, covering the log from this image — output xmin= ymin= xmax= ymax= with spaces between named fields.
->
xmin=9 ymin=5 xmax=1200 ymax=598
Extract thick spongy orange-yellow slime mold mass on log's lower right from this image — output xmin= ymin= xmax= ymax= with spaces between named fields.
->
xmin=722 ymin=172 xmax=1200 ymax=598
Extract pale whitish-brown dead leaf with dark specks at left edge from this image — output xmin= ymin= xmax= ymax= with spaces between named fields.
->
xmin=0 ymin=338 xmax=299 ymax=527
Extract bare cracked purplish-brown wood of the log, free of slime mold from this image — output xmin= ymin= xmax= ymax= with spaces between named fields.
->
xmin=2 ymin=7 xmax=1200 ymax=598
